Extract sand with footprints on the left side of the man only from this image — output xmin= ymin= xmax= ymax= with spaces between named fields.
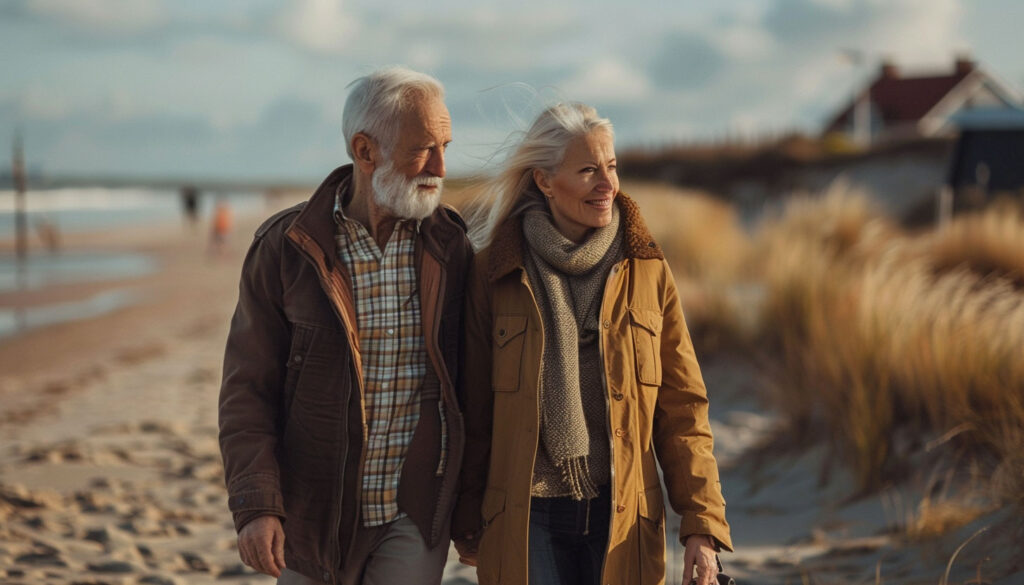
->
xmin=0 ymin=200 xmax=288 ymax=584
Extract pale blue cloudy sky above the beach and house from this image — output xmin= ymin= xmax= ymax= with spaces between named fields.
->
xmin=0 ymin=0 xmax=1024 ymax=181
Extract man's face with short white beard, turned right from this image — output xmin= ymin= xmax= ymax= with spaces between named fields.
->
xmin=373 ymin=97 xmax=452 ymax=219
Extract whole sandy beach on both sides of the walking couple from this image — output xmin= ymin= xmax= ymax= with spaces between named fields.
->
xmin=0 ymin=188 xmax=1012 ymax=585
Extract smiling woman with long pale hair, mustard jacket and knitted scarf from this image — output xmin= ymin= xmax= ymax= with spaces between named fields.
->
xmin=452 ymin=103 xmax=731 ymax=585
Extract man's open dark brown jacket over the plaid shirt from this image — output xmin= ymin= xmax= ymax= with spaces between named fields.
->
xmin=220 ymin=165 xmax=472 ymax=583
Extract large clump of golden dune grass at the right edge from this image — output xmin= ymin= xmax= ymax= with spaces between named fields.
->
xmin=757 ymin=185 xmax=1024 ymax=495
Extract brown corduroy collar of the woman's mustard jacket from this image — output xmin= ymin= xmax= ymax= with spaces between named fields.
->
xmin=487 ymin=192 xmax=665 ymax=282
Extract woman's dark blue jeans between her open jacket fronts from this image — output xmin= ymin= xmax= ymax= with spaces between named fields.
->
xmin=529 ymin=486 xmax=611 ymax=585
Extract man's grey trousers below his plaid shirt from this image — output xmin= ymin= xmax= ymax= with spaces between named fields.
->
xmin=278 ymin=516 xmax=450 ymax=585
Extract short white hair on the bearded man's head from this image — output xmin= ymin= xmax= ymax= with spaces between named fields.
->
xmin=341 ymin=67 xmax=444 ymax=160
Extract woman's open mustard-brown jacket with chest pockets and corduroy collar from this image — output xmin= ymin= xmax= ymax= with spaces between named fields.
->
xmin=452 ymin=194 xmax=732 ymax=585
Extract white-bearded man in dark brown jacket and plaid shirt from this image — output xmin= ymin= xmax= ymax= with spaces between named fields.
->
xmin=220 ymin=68 xmax=472 ymax=585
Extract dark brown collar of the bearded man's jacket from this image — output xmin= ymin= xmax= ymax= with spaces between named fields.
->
xmin=288 ymin=164 xmax=465 ymax=269
